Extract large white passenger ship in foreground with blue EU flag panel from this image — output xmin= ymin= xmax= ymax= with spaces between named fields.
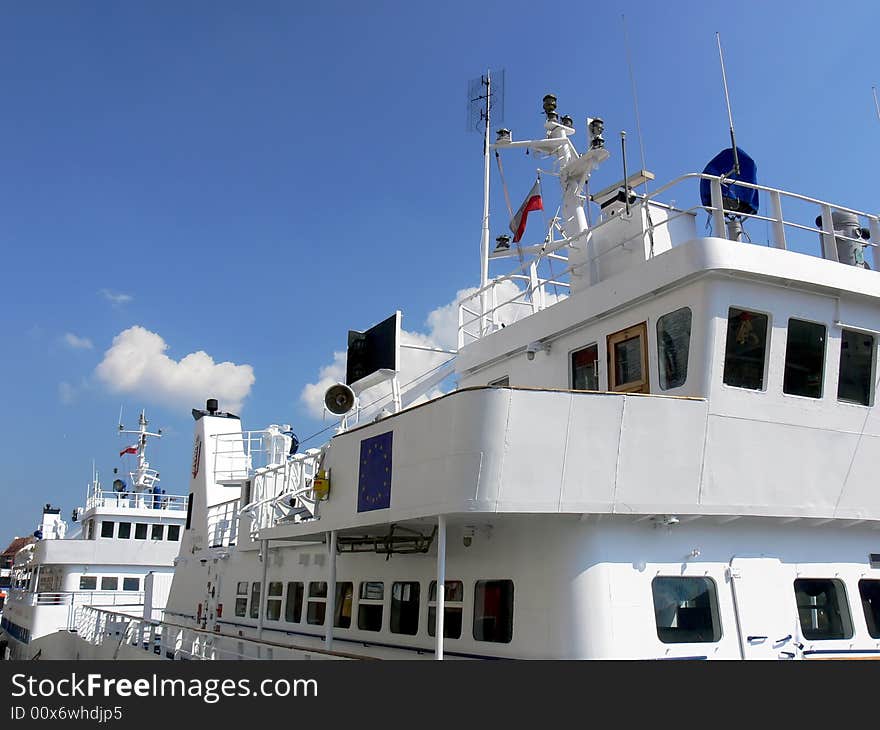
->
xmin=70 ymin=88 xmax=880 ymax=659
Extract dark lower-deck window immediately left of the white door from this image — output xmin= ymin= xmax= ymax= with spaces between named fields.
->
xmin=651 ymin=576 xmax=721 ymax=644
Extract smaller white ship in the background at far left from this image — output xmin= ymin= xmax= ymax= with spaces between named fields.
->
xmin=0 ymin=413 xmax=187 ymax=659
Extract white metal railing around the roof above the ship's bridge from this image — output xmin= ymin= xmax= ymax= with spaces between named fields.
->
xmin=458 ymin=173 xmax=880 ymax=348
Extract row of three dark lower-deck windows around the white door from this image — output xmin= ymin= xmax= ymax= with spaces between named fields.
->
xmin=651 ymin=576 xmax=880 ymax=644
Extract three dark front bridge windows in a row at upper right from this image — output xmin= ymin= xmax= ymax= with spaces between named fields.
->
xmin=724 ymin=307 xmax=875 ymax=406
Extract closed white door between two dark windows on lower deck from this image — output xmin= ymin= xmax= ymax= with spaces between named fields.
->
xmin=729 ymin=557 xmax=800 ymax=659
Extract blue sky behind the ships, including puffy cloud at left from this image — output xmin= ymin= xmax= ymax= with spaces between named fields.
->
xmin=0 ymin=0 xmax=880 ymax=545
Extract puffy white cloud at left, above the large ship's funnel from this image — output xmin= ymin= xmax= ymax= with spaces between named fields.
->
xmin=95 ymin=326 xmax=255 ymax=413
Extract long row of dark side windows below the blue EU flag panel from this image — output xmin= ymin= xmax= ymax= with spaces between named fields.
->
xmin=235 ymin=580 xmax=513 ymax=643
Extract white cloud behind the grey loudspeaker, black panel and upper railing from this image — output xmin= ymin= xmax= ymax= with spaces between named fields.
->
xmin=300 ymin=281 xmax=560 ymax=418
